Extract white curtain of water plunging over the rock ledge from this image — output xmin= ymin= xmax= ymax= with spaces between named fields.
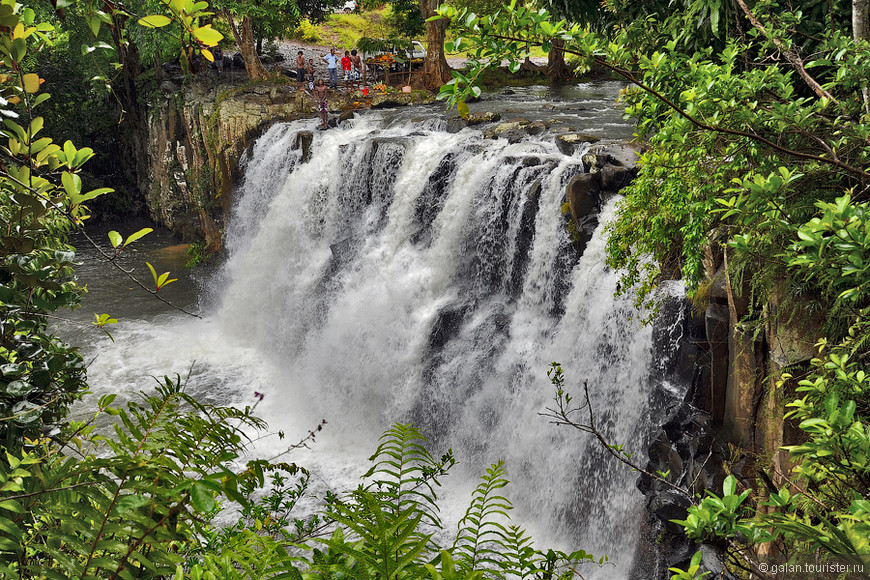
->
xmin=217 ymin=112 xmax=651 ymax=573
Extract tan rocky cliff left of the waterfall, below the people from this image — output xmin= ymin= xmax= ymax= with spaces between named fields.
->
xmin=137 ymin=75 xmax=433 ymax=253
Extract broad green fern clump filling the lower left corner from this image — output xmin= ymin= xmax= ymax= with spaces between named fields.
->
xmin=0 ymin=378 xmax=264 ymax=578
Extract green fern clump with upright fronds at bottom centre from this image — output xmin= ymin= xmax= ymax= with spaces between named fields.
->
xmin=179 ymin=425 xmax=606 ymax=580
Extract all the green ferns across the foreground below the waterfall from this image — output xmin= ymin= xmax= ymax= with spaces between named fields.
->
xmin=0 ymin=404 xmax=604 ymax=580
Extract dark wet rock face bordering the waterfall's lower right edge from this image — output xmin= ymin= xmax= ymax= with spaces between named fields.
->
xmin=629 ymin=298 xmax=742 ymax=580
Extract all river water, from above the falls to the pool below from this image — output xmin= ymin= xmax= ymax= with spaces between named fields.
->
xmin=60 ymin=83 xmax=692 ymax=578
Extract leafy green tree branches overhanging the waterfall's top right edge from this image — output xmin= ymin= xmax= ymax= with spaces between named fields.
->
xmin=440 ymin=0 xmax=870 ymax=327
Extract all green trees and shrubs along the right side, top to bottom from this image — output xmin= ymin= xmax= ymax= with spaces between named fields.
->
xmin=441 ymin=0 xmax=870 ymax=578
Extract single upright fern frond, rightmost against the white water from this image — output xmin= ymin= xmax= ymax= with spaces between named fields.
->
xmin=453 ymin=461 xmax=513 ymax=570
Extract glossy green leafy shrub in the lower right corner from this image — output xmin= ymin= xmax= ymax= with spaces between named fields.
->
xmin=664 ymin=322 xmax=870 ymax=564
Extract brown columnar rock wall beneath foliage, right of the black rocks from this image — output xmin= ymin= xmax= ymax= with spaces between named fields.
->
xmin=633 ymin=244 xmax=822 ymax=578
